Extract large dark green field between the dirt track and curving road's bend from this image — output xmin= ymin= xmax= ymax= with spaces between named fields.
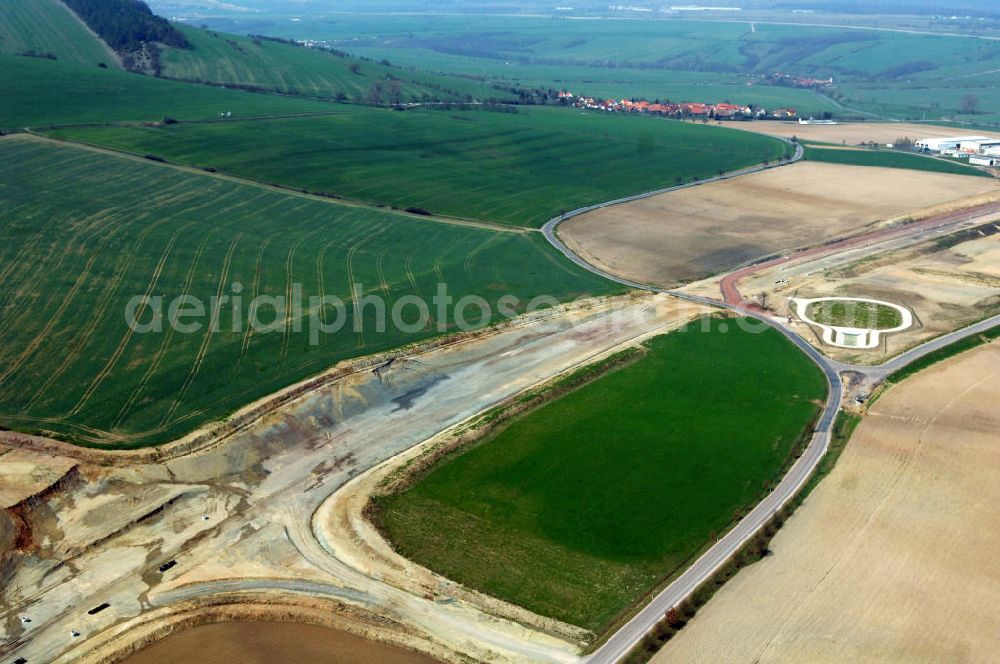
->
xmin=53 ymin=106 xmax=789 ymax=226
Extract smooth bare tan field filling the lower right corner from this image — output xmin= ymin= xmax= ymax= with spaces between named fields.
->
xmin=653 ymin=343 xmax=1000 ymax=664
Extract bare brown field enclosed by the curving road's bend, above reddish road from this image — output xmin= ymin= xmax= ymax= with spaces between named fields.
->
xmin=559 ymin=162 xmax=998 ymax=286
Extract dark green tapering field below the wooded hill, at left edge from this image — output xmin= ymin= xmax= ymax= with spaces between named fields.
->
xmin=0 ymin=55 xmax=342 ymax=130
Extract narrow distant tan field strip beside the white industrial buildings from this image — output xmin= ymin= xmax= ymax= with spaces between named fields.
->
xmin=726 ymin=122 xmax=1000 ymax=145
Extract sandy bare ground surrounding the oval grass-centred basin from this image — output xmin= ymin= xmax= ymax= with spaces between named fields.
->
xmin=741 ymin=223 xmax=1000 ymax=364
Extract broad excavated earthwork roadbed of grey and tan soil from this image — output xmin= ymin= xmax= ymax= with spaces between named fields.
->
xmin=0 ymin=293 xmax=710 ymax=664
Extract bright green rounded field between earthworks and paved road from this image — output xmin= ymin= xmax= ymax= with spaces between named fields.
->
xmin=378 ymin=319 xmax=825 ymax=634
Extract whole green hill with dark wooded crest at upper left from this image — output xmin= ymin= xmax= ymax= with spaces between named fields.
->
xmin=0 ymin=0 xmax=507 ymax=105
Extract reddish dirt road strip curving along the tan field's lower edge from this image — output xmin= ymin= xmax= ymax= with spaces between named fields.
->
xmin=719 ymin=203 xmax=1000 ymax=311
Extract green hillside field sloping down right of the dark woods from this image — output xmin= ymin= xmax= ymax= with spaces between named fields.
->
xmin=163 ymin=27 xmax=498 ymax=103
